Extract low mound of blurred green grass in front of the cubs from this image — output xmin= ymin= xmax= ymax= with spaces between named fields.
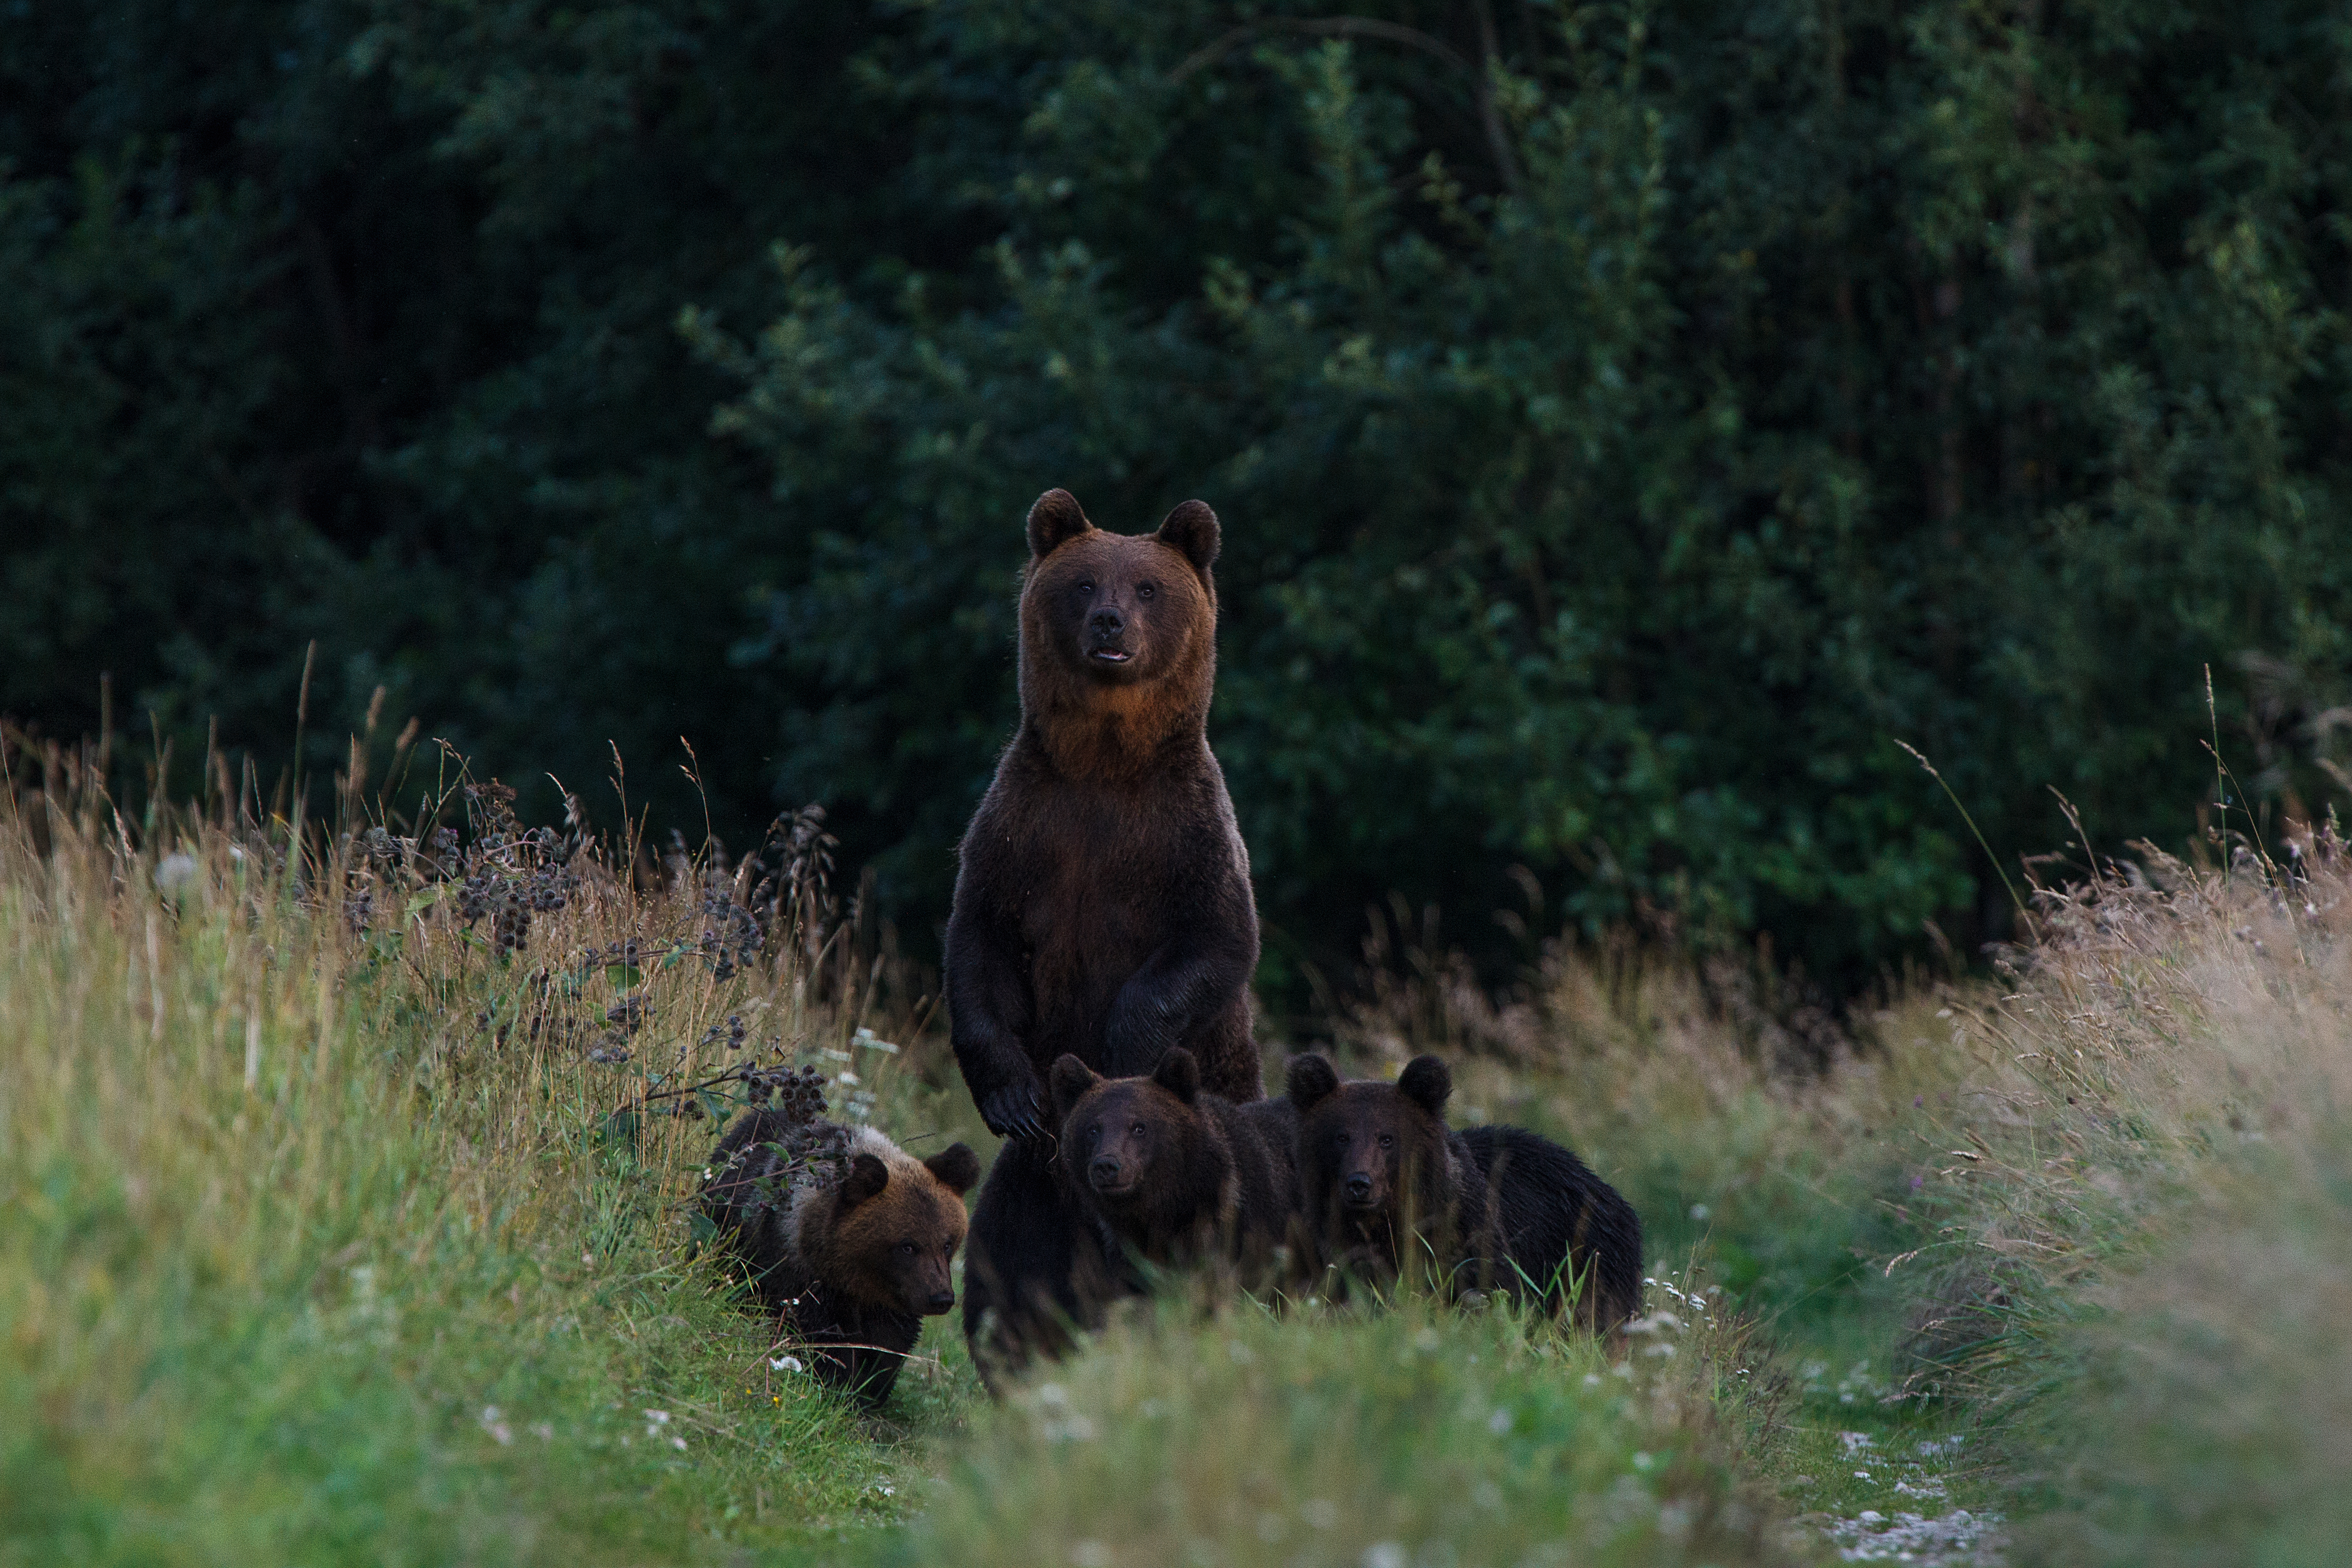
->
xmin=899 ymin=1302 xmax=1792 ymax=1568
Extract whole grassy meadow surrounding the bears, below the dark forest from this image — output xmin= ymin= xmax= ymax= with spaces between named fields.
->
xmin=0 ymin=757 xmax=2352 ymax=1568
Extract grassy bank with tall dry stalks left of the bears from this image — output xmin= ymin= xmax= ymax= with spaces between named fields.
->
xmin=0 ymin=743 xmax=969 ymax=1563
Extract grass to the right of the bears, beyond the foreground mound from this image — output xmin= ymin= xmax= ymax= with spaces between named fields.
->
xmin=1298 ymin=832 xmax=2352 ymax=1563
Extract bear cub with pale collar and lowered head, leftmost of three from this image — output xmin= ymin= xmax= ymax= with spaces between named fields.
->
xmin=703 ymin=1110 xmax=981 ymax=1406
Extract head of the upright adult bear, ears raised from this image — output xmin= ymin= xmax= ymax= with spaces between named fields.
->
xmin=1021 ymin=491 xmax=1216 ymax=687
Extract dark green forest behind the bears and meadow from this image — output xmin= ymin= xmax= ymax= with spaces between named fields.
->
xmin=0 ymin=0 xmax=2352 ymax=988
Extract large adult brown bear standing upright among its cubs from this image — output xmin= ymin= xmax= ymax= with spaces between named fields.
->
xmin=948 ymin=489 xmax=1261 ymax=1373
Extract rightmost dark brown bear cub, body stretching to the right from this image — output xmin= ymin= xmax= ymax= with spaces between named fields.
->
xmin=1289 ymin=1055 xmax=1642 ymax=1331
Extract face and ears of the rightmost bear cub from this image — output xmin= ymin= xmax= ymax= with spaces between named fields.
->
xmin=1286 ymin=1055 xmax=1453 ymax=1222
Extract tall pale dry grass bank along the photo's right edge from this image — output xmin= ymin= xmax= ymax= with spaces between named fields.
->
xmin=1910 ymin=832 xmax=2352 ymax=1563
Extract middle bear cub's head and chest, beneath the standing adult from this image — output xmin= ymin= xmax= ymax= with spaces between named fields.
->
xmin=1051 ymin=1046 xmax=1298 ymax=1284
